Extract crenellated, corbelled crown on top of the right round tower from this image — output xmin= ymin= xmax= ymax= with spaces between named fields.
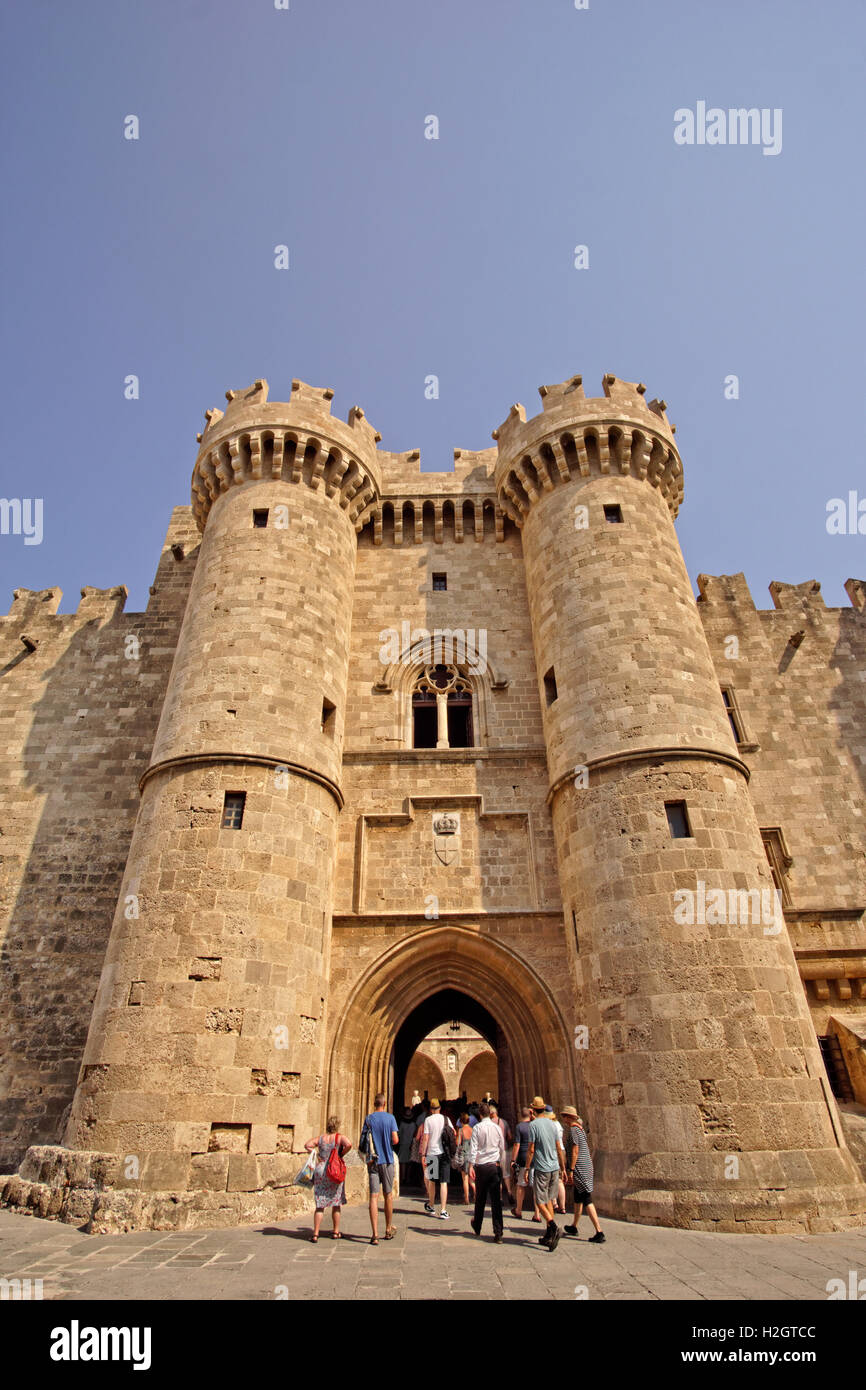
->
xmin=493 ymin=374 xmax=683 ymax=525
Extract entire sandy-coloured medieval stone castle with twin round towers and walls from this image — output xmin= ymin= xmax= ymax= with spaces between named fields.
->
xmin=0 ymin=377 xmax=866 ymax=1232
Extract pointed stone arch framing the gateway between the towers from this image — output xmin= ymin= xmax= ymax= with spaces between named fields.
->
xmin=325 ymin=924 xmax=578 ymax=1125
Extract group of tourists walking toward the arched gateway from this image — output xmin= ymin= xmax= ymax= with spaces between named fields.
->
xmin=304 ymin=1093 xmax=605 ymax=1251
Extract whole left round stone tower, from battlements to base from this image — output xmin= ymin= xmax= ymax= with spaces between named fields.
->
xmin=67 ymin=381 xmax=379 ymax=1225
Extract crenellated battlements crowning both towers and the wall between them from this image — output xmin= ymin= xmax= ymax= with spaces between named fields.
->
xmin=192 ymin=374 xmax=683 ymax=533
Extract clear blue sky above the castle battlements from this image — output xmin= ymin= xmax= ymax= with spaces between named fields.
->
xmin=0 ymin=0 xmax=866 ymax=612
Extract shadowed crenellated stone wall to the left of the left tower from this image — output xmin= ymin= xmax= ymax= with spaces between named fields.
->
xmin=0 ymin=507 xmax=200 ymax=1172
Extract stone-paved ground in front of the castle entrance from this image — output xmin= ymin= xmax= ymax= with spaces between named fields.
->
xmin=0 ymin=1197 xmax=866 ymax=1300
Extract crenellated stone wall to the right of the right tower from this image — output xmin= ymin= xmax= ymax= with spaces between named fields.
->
xmin=698 ymin=574 xmax=866 ymax=1034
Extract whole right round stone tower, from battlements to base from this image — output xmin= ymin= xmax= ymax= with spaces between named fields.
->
xmin=493 ymin=377 xmax=866 ymax=1230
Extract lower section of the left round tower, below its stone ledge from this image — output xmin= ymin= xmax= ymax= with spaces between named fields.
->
xmin=65 ymin=762 xmax=336 ymax=1167
